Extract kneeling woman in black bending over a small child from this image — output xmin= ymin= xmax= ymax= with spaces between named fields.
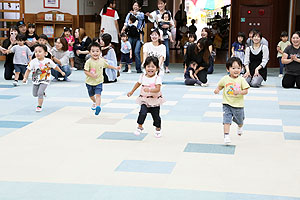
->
xmin=184 ymin=38 xmax=210 ymax=83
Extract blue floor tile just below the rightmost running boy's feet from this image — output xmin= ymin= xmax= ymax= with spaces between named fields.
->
xmin=184 ymin=143 xmax=235 ymax=154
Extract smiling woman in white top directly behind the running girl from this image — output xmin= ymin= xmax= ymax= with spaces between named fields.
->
xmin=143 ymin=28 xmax=166 ymax=79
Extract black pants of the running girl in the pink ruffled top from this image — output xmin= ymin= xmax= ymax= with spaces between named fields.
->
xmin=137 ymin=104 xmax=161 ymax=128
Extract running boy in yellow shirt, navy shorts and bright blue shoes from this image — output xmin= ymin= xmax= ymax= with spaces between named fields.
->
xmin=84 ymin=42 xmax=120 ymax=115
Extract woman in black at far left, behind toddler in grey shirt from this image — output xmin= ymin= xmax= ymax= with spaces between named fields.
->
xmin=2 ymin=26 xmax=19 ymax=80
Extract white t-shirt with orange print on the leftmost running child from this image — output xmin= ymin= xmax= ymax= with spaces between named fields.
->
xmin=27 ymin=58 xmax=56 ymax=85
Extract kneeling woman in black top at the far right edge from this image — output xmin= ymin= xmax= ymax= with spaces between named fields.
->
xmin=282 ymin=31 xmax=300 ymax=89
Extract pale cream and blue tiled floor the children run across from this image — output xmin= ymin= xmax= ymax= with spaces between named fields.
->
xmin=0 ymin=63 xmax=300 ymax=200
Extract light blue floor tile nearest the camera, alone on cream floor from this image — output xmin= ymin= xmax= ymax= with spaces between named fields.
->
xmin=115 ymin=160 xmax=176 ymax=174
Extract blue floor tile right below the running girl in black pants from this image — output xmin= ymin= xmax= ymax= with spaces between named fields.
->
xmin=97 ymin=132 xmax=147 ymax=141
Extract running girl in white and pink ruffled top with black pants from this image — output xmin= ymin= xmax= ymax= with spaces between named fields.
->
xmin=127 ymin=56 xmax=164 ymax=138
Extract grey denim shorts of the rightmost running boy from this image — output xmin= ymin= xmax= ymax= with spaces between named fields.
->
xmin=223 ymin=104 xmax=245 ymax=125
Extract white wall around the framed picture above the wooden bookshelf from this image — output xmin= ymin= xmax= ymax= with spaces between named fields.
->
xmin=24 ymin=0 xmax=77 ymax=15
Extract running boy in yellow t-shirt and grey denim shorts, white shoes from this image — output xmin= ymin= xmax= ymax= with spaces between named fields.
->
xmin=214 ymin=57 xmax=250 ymax=145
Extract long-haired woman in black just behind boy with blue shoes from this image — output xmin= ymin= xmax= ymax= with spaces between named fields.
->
xmin=73 ymin=28 xmax=92 ymax=69
